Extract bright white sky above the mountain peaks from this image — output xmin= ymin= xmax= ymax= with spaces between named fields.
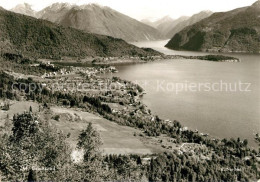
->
xmin=0 ymin=0 xmax=256 ymax=20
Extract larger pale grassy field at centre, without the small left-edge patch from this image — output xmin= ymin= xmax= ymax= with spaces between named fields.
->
xmin=51 ymin=107 xmax=156 ymax=154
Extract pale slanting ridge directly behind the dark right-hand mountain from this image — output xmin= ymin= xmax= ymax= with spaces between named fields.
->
xmin=165 ymin=11 xmax=213 ymax=38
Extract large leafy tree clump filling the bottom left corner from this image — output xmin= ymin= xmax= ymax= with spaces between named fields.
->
xmin=0 ymin=112 xmax=72 ymax=181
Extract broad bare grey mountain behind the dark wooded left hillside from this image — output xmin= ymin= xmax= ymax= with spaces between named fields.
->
xmin=37 ymin=3 xmax=161 ymax=41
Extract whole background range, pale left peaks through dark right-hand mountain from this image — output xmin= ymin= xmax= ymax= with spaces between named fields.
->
xmin=8 ymin=0 xmax=260 ymax=52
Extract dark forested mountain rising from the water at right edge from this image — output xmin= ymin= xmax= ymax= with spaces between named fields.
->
xmin=166 ymin=0 xmax=260 ymax=53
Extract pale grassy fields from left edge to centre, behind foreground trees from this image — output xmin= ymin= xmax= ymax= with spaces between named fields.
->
xmin=0 ymin=101 xmax=164 ymax=154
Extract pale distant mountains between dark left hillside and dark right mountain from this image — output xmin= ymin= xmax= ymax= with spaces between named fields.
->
xmin=11 ymin=3 xmax=212 ymax=42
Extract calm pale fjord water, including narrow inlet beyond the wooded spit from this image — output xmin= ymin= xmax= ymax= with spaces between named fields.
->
xmin=116 ymin=41 xmax=260 ymax=146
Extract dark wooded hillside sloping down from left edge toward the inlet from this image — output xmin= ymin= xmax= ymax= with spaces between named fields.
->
xmin=0 ymin=9 xmax=160 ymax=59
